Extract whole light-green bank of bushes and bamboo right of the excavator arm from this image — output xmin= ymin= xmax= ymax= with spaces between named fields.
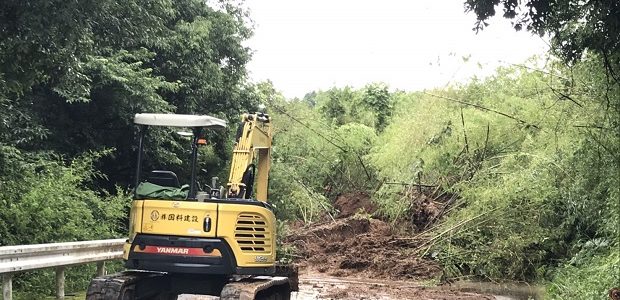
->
xmin=272 ymin=57 xmax=620 ymax=299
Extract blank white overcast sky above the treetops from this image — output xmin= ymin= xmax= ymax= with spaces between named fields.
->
xmin=246 ymin=0 xmax=547 ymax=97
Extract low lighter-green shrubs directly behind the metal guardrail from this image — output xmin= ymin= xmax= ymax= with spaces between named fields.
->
xmin=0 ymin=146 xmax=129 ymax=299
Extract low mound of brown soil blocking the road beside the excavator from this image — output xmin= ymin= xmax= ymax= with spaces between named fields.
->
xmin=286 ymin=215 xmax=440 ymax=279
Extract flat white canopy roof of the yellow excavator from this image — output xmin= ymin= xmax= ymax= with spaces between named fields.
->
xmin=133 ymin=114 xmax=226 ymax=128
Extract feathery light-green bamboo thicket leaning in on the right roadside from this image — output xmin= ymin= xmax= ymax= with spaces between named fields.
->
xmin=372 ymin=56 xmax=620 ymax=299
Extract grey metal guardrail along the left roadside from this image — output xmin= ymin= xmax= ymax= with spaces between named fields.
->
xmin=0 ymin=239 xmax=125 ymax=300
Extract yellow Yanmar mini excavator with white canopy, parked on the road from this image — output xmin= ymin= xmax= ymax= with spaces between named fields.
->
xmin=86 ymin=112 xmax=297 ymax=300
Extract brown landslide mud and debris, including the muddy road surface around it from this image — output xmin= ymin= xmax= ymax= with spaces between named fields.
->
xmin=284 ymin=193 xmax=494 ymax=300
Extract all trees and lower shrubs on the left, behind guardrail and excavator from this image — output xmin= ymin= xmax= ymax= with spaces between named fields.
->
xmin=0 ymin=0 xmax=258 ymax=298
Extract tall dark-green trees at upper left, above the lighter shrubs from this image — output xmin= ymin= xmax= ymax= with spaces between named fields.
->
xmin=0 ymin=0 xmax=256 ymax=190
